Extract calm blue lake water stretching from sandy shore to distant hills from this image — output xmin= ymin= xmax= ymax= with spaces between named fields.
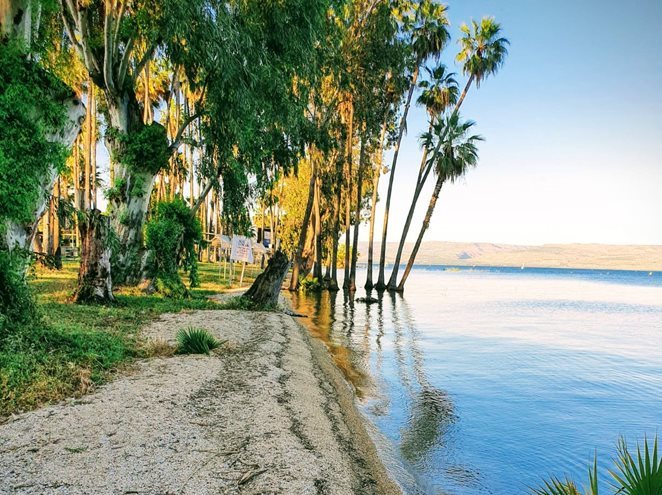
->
xmin=293 ymin=267 xmax=662 ymax=495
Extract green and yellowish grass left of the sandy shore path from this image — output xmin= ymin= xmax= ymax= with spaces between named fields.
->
xmin=0 ymin=261 xmax=258 ymax=417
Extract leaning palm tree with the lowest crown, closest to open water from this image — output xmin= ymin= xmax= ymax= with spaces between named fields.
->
xmin=396 ymin=112 xmax=483 ymax=292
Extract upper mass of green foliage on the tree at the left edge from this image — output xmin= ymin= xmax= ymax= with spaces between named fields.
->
xmin=0 ymin=41 xmax=72 ymax=228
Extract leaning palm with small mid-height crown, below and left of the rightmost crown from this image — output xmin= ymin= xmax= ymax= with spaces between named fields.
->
xmin=387 ymin=64 xmax=458 ymax=290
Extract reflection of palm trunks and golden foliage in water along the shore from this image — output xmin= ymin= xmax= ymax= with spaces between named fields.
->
xmin=291 ymin=286 xmax=455 ymax=488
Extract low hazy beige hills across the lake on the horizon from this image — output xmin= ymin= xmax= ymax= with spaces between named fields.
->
xmin=359 ymin=241 xmax=662 ymax=271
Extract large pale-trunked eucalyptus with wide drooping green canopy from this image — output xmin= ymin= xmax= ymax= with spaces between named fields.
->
xmin=60 ymin=0 xmax=327 ymax=282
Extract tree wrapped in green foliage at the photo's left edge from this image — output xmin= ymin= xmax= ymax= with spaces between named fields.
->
xmin=0 ymin=0 xmax=85 ymax=330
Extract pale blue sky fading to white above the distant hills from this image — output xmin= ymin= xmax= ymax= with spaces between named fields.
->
xmin=374 ymin=0 xmax=662 ymax=245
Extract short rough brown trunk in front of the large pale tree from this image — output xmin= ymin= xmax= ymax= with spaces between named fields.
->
xmin=74 ymin=210 xmax=115 ymax=304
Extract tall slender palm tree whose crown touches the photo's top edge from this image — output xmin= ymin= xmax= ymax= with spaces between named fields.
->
xmin=375 ymin=0 xmax=450 ymax=290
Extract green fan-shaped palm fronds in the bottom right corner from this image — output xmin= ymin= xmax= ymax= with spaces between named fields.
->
xmin=532 ymin=436 xmax=662 ymax=495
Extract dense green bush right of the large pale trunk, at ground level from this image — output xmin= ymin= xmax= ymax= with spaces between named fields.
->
xmin=146 ymin=198 xmax=202 ymax=298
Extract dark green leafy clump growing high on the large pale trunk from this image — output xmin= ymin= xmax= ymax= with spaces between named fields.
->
xmin=106 ymin=122 xmax=170 ymax=177
